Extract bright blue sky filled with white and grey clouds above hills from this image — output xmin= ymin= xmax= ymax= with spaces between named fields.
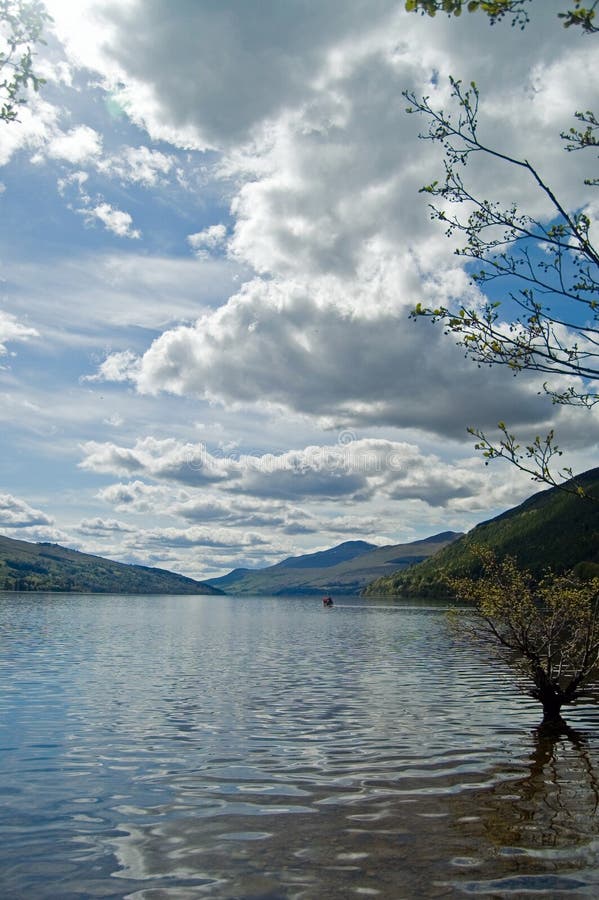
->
xmin=0 ymin=0 xmax=599 ymax=578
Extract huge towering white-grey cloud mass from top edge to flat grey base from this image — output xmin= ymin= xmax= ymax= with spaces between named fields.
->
xmin=71 ymin=0 xmax=599 ymax=450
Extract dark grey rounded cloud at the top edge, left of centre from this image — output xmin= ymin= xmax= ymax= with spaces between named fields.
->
xmin=85 ymin=0 xmax=395 ymax=148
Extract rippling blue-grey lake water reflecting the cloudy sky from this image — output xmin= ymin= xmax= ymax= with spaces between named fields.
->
xmin=0 ymin=594 xmax=599 ymax=900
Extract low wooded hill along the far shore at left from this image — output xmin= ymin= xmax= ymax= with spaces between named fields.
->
xmin=0 ymin=535 xmax=223 ymax=594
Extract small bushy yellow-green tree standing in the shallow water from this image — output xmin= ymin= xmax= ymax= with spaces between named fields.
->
xmin=447 ymin=547 xmax=599 ymax=721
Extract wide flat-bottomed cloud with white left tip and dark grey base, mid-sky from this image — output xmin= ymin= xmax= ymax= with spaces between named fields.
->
xmin=90 ymin=275 xmax=576 ymax=439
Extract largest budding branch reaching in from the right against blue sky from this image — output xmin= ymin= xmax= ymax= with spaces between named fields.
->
xmin=404 ymin=79 xmax=599 ymax=394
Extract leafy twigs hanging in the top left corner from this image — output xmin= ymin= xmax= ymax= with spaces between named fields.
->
xmin=0 ymin=0 xmax=50 ymax=122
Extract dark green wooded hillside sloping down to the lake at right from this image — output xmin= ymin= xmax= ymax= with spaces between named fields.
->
xmin=364 ymin=468 xmax=599 ymax=597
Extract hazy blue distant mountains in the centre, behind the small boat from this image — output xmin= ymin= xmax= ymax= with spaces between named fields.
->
xmin=208 ymin=531 xmax=459 ymax=595
